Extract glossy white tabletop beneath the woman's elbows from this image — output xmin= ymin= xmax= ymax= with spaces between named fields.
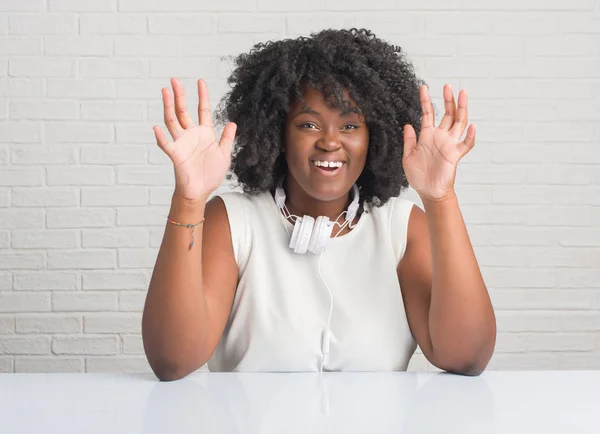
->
xmin=0 ymin=371 xmax=600 ymax=434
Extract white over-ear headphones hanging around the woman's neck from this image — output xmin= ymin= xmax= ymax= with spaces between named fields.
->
xmin=275 ymin=177 xmax=359 ymax=255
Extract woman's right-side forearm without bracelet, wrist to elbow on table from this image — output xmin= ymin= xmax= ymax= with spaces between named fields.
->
xmin=423 ymin=195 xmax=496 ymax=372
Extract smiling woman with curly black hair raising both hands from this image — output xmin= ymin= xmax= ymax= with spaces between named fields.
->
xmin=142 ymin=29 xmax=496 ymax=380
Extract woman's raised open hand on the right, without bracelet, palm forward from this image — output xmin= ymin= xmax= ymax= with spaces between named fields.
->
xmin=402 ymin=85 xmax=475 ymax=201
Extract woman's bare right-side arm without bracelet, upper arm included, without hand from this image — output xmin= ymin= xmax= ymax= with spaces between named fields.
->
xmin=398 ymin=198 xmax=496 ymax=375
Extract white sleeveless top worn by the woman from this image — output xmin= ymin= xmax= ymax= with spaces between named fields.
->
xmin=207 ymin=192 xmax=417 ymax=372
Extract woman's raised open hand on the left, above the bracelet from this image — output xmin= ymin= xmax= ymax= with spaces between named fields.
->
xmin=153 ymin=78 xmax=237 ymax=201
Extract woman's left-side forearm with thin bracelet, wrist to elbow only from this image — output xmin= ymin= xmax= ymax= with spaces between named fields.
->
xmin=142 ymin=196 xmax=207 ymax=379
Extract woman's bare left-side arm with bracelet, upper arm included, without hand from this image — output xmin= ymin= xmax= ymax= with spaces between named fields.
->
xmin=142 ymin=196 xmax=237 ymax=381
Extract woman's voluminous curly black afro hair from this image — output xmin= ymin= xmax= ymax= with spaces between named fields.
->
xmin=215 ymin=28 xmax=425 ymax=206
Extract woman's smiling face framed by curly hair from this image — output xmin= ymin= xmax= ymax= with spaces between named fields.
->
xmin=284 ymin=87 xmax=369 ymax=201
